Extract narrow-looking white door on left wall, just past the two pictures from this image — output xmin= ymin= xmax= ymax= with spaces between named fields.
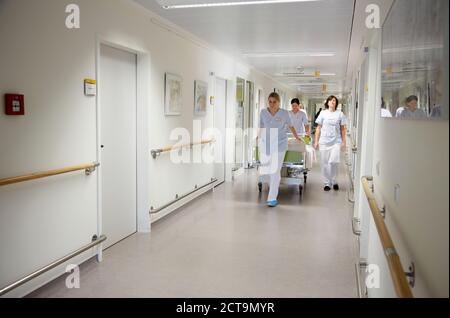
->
xmin=214 ymin=78 xmax=227 ymax=183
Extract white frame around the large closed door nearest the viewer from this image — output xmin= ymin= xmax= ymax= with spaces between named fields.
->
xmin=95 ymin=34 xmax=151 ymax=261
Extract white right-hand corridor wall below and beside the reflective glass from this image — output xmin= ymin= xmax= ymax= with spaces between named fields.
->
xmin=355 ymin=22 xmax=449 ymax=297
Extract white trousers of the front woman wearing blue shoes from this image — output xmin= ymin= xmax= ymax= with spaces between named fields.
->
xmin=259 ymin=151 xmax=286 ymax=201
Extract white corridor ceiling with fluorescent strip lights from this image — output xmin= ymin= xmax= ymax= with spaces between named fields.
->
xmin=135 ymin=0 xmax=355 ymax=95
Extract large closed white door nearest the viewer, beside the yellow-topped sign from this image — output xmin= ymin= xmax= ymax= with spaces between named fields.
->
xmin=99 ymin=45 xmax=137 ymax=248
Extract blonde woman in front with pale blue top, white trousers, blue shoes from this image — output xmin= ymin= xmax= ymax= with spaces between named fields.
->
xmin=259 ymin=93 xmax=302 ymax=207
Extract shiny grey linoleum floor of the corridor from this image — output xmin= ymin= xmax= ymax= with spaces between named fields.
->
xmin=28 ymin=165 xmax=357 ymax=298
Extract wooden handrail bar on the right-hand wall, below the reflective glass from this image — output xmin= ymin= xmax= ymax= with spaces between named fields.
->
xmin=362 ymin=177 xmax=414 ymax=298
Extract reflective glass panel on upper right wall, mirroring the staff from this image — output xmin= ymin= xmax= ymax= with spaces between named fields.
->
xmin=380 ymin=0 xmax=448 ymax=120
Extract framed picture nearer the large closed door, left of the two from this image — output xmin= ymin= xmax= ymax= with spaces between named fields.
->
xmin=164 ymin=73 xmax=183 ymax=116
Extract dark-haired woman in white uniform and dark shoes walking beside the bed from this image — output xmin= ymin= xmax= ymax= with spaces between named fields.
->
xmin=314 ymin=96 xmax=347 ymax=191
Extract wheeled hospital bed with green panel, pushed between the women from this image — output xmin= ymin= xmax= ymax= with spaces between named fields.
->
xmin=255 ymin=137 xmax=314 ymax=196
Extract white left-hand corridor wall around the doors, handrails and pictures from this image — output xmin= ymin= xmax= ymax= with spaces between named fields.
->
xmin=0 ymin=0 xmax=295 ymax=296
